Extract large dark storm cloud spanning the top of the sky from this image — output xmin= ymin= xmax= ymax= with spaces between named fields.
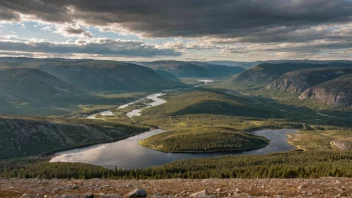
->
xmin=0 ymin=0 xmax=352 ymax=42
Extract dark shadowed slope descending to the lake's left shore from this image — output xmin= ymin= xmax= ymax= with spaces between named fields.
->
xmin=0 ymin=118 xmax=145 ymax=158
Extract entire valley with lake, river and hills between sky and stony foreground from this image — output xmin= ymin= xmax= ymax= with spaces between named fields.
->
xmin=0 ymin=58 xmax=352 ymax=197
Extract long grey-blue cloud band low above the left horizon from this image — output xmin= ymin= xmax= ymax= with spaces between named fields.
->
xmin=0 ymin=39 xmax=181 ymax=57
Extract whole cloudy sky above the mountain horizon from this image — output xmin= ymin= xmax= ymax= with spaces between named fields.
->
xmin=0 ymin=0 xmax=352 ymax=61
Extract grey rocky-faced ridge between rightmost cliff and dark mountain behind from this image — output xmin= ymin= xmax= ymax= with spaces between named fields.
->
xmin=266 ymin=67 xmax=352 ymax=93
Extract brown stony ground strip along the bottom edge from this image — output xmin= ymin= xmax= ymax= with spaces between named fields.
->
xmin=0 ymin=178 xmax=352 ymax=198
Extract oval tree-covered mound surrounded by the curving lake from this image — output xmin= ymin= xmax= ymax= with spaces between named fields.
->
xmin=139 ymin=127 xmax=269 ymax=153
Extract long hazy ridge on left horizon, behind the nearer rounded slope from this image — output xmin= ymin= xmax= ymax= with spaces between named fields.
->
xmin=0 ymin=58 xmax=186 ymax=92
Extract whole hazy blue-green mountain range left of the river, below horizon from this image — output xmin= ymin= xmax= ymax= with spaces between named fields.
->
xmin=0 ymin=58 xmax=185 ymax=115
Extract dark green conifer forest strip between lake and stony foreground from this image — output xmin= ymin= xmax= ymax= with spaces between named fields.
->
xmin=0 ymin=151 xmax=352 ymax=179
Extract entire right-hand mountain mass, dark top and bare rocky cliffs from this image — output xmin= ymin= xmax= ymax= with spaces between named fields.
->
xmin=230 ymin=61 xmax=352 ymax=107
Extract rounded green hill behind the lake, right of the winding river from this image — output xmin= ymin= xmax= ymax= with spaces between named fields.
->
xmin=143 ymin=90 xmax=278 ymax=117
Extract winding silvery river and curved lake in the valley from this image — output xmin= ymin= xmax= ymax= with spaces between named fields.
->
xmin=50 ymin=88 xmax=297 ymax=168
